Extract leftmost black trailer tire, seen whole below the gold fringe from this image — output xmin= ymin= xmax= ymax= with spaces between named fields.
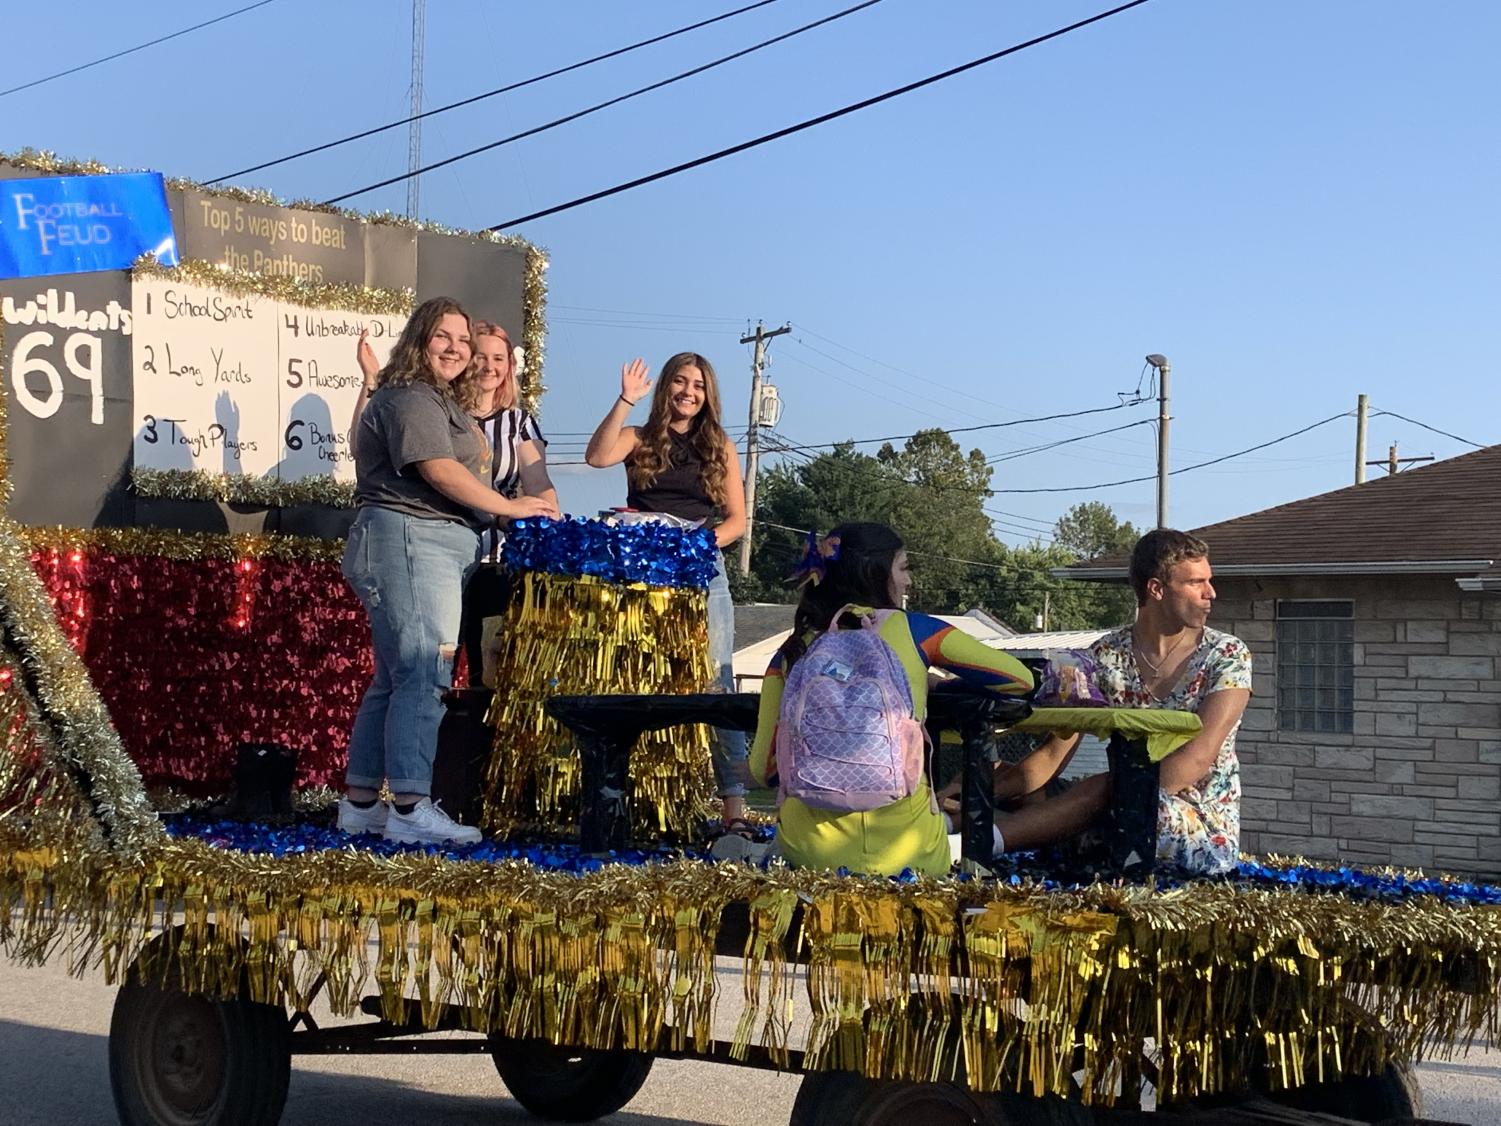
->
xmin=110 ymin=965 xmax=291 ymax=1126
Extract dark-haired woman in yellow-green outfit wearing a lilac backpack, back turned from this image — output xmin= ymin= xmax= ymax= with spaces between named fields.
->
xmin=751 ymin=524 xmax=1033 ymax=875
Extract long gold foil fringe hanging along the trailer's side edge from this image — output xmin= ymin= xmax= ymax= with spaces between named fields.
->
xmin=0 ymin=841 xmax=1501 ymax=1103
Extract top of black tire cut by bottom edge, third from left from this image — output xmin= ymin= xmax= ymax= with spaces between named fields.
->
xmin=790 ymin=1072 xmax=1009 ymax=1126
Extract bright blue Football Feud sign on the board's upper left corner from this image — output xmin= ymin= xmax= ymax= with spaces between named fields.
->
xmin=0 ymin=173 xmax=177 ymax=278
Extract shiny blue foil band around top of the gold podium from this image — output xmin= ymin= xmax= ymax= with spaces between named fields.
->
xmin=501 ymin=516 xmax=719 ymax=590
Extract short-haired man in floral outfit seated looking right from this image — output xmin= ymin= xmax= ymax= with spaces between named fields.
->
xmin=1090 ymin=528 xmax=1250 ymax=874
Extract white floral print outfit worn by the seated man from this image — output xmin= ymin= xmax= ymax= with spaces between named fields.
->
xmin=1090 ymin=626 xmax=1250 ymax=874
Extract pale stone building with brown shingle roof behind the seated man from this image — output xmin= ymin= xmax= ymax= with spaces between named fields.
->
xmin=1066 ymin=446 xmax=1501 ymax=878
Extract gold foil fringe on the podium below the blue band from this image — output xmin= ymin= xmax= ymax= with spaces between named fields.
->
xmin=485 ymin=572 xmax=713 ymax=838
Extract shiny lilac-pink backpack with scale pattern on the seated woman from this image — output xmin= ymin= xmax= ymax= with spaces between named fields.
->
xmin=776 ymin=607 xmax=928 ymax=812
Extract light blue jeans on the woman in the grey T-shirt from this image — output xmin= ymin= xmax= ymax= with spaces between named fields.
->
xmin=344 ymin=507 xmax=479 ymax=794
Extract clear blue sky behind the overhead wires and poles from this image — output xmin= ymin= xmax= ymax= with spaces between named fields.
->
xmin=0 ymin=0 xmax=1501 ymax=543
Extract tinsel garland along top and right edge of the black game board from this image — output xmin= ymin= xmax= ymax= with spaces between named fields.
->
xmin=0 ymin=149 xmax=548 ymax=402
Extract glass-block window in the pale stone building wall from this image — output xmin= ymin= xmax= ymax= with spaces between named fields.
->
xmin=1277 ymin=599 xmax=1355 ymax=733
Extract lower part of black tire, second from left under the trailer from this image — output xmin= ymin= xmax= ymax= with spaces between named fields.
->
xmin=489 ymin=1034 xmax=656 ymax=1121
